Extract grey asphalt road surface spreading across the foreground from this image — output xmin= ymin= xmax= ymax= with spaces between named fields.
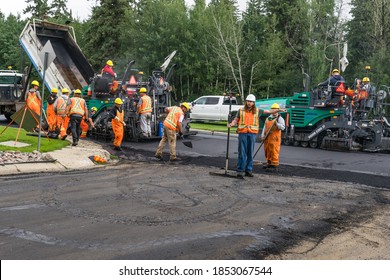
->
xmin=0 ymin=136 xmax=390 ymax=259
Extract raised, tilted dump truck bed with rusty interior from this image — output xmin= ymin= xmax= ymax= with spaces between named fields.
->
xmin=19 ymin=20 xmax=94 ymax=92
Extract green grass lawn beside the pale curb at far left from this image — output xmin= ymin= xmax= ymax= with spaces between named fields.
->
xmin=0 ymin=125 xmax=70 ymax=153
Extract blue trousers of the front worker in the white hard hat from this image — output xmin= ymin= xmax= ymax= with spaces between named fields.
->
xmin=237 ymin=133 xmax=256 ymax=172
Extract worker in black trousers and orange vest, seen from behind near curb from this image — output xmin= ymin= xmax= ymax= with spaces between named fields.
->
xmin=65 ymin=89 xmax=88 ymax=146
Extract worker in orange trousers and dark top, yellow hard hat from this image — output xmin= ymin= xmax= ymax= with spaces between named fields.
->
xmin=108 ymin=98 xmax=126 ymax=151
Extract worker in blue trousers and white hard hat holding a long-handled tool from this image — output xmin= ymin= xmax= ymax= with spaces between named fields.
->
xmin=228 ymin=94 xmax=280 ymax=178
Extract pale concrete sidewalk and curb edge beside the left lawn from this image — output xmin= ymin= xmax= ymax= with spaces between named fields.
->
xmin=0 ymin=140 xmax=110 ymax=176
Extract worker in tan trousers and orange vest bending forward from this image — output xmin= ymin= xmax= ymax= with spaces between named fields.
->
xmin=155 ymin=102 xmax=190 ymax=162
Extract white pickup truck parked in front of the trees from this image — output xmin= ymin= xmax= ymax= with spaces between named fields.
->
xmin=190 ymin=95 xmax=243 ymax=121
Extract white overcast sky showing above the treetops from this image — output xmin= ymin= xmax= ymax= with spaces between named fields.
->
xmin=0 ymin=0 xmax=246 ymax=20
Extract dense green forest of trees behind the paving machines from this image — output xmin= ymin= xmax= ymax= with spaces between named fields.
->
xmin=0 ymin=0 xmax=390 ymax=100
